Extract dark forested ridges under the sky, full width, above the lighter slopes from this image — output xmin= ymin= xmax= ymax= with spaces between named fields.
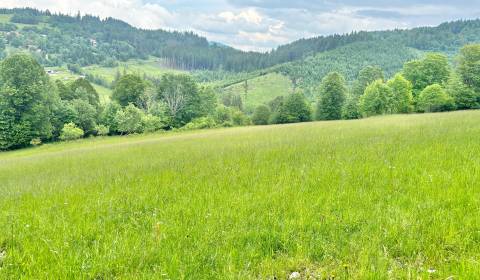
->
xmin=0 ymin=9 xmax=480 ymax=72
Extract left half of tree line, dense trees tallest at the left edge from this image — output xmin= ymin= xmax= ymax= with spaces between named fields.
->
xmin=0 ymin=54 xmax=250 ymax=150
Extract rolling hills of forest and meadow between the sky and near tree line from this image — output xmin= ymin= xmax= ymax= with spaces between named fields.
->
xmin=0 ymin=9 xmax=480 ymax=108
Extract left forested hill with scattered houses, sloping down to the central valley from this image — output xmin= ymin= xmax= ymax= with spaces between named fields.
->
xmin=0 ymin=9 xmax=263 ymax=70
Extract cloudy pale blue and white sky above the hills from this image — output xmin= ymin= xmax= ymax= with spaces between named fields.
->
xmin=0 ymin=0 xmax=480 ymax=51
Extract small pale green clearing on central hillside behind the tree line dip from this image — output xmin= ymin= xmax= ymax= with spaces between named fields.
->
xmin=224 ymin=73 xmax=293 ymax=111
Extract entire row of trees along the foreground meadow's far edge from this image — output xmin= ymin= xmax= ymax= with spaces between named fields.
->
xmin=0 ymin=44 xmax=480 ymax=150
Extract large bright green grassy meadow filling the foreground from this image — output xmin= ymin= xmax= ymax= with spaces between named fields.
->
xmin=0 ymin=111 xmax=480 ymax=279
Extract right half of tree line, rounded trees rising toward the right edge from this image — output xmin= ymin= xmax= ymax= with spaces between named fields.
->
xmin=248 ymin=44 xmax=480 ymax=125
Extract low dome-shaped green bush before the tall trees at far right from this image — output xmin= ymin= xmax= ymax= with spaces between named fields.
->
xmin=417 ymin=84 xmax=455 ymax=113
